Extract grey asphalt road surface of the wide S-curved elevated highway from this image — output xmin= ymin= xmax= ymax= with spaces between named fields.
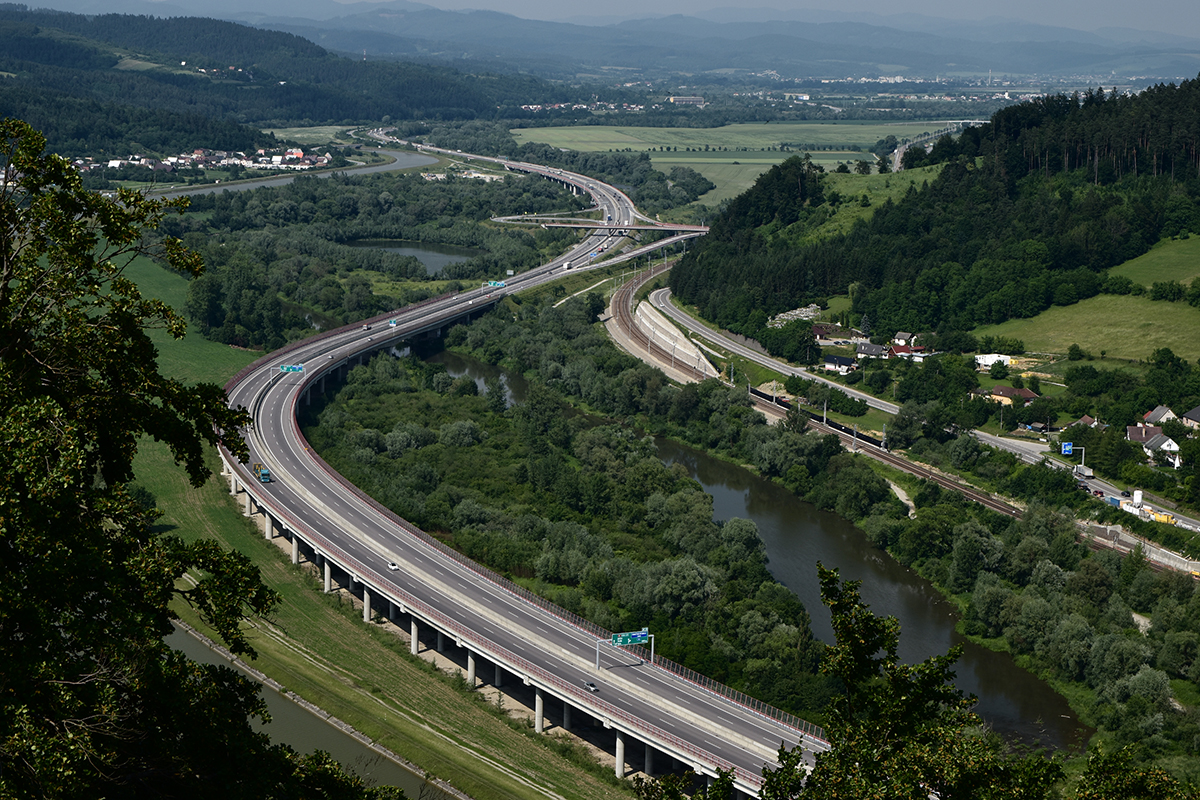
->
xmin=227 ymin=159 xmax=824 ymax=793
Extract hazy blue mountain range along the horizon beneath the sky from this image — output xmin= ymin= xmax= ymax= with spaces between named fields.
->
xmin=14 ymin=0 xmax=1200 ymax=80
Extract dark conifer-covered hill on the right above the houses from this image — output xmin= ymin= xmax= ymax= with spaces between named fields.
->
xmin=671 ymin=79 xmax=1200 ymax=336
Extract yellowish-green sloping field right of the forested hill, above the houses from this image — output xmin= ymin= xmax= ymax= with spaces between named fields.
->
xmin=972 ymin=295 xmax=1200 ymax=360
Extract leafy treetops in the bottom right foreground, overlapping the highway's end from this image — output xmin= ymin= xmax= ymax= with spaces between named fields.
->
xmin=744 ymin=564 xmax=1189 ymax=800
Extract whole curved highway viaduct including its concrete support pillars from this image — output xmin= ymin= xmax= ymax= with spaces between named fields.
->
xmin=223 ymin=159 xmax=827 ymax=795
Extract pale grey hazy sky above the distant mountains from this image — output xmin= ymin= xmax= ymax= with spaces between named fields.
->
xmin=343 ymin=0 xmax=1200 ymax=36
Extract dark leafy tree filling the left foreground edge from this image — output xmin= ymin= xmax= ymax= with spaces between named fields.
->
xmin=0 ymin=120 xmax=400 ymax=798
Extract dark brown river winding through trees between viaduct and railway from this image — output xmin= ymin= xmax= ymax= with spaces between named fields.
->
xmin=430 ymin=351 xmax=1091 ymax=748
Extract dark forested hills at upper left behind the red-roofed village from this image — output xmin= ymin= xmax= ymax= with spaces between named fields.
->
xmin=0 ymin=5 xmax=569 ymax=146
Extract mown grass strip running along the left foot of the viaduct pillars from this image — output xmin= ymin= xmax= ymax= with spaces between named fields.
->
xmin=126 ymin=259 xmax=629 ymax=800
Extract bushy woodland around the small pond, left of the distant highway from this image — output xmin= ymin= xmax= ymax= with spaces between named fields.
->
xmin=168 ymin=173 xmax=582 ymax=349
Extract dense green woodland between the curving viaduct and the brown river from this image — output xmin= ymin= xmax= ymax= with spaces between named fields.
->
xmin=302 ymin=347 xmax=836 ymax=715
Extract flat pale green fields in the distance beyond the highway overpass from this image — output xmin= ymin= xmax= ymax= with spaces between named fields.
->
xmin=511 ymin=121 xmax=960 ymax=205
